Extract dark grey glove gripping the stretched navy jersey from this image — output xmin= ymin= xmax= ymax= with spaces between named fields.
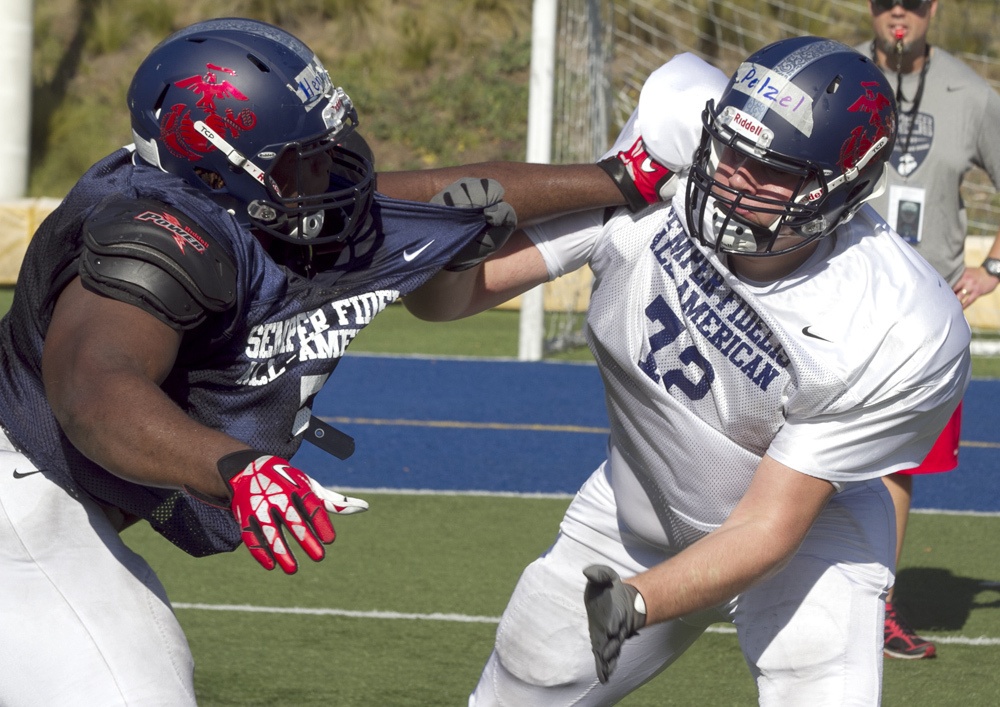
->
xmin=431 ymin=177 xmax=517 ymax=271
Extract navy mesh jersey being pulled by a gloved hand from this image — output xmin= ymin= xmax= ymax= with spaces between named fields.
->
xmin=0 ymin=150 xmax=485 ymax=556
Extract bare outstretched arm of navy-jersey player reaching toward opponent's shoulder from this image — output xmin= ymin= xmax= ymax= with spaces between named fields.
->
xmin=378 ymin=162 xmax=625 ymax=226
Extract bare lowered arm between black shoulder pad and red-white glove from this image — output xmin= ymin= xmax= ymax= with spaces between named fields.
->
xmin=42 ymin=279 xmax=247 ymax=497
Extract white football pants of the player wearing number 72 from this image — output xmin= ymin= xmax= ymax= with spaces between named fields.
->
xmin=469 ymin=466 xmax=895 ymax=707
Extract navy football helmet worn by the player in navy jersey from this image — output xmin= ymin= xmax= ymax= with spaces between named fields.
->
xmin=128 ymin=18 xmax=375 ymax=246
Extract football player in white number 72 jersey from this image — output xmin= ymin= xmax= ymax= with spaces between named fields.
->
xmin=405 ymin=37 xmax=969 ymax=707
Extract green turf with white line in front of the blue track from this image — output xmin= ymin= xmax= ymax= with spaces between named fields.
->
xmin=126 ymin=500 xmax=1000 ymax=707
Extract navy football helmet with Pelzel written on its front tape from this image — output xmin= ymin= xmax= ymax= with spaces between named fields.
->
xmin=687 ymin=37 xmax=896 ymax=255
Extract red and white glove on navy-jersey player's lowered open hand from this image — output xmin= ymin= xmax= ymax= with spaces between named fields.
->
xmin=218 ymin=450 xmax=368 ymax=574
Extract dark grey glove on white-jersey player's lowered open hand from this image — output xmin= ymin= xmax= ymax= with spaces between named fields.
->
xmin=583 ymin=565 xmax=646 ymax=682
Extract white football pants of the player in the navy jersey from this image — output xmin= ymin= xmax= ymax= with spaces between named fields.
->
xmin=0 ymin=433 xmax=195 ymax=707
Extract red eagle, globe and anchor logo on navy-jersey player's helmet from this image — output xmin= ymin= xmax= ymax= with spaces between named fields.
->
xmin=160 ymin=64 xmax=257 ymax=162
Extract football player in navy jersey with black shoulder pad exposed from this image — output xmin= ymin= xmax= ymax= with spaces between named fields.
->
xmin=0 ymin=18 xmax=652 ymax=706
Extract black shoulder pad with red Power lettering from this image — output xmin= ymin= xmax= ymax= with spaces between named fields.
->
xmin=80 ymin=199 xmax=236 ymax=330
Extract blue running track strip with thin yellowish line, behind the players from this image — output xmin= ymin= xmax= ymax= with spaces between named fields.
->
xmin=295 ymin=354 xmax=1000 ymax=513
